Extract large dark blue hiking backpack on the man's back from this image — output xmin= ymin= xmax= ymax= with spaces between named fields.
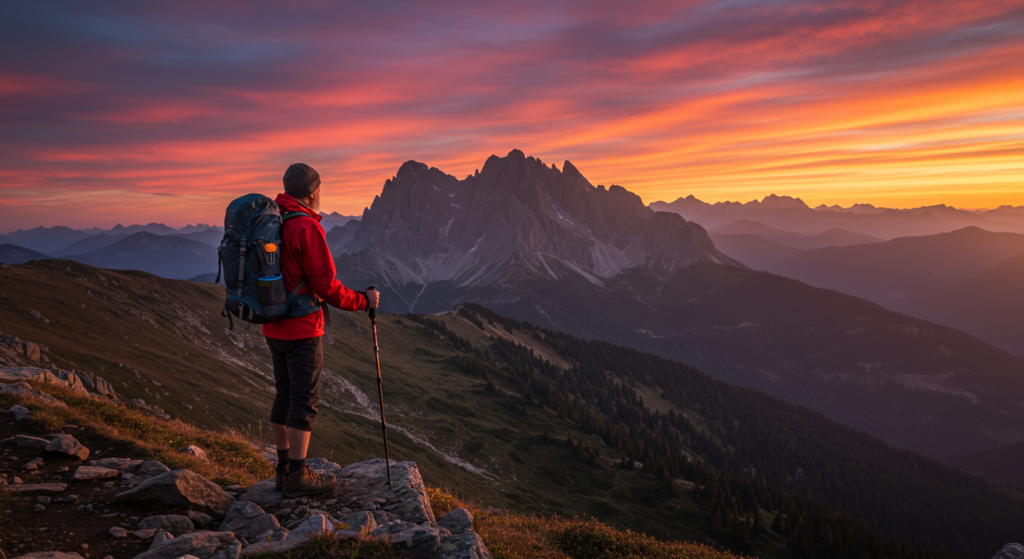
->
xmin=215 ymin=195 xmax=326 ymax=330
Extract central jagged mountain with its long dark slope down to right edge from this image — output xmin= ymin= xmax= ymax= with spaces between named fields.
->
xmin=331 ymin=151 xmax=1024 ymax=457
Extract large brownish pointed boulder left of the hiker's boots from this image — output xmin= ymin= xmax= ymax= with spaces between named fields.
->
xmin=116 ymin=470 xmax=234 ymax=513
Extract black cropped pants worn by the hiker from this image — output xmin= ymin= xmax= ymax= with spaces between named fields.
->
xmin=266 ymin=336 xmax=324 ymax=431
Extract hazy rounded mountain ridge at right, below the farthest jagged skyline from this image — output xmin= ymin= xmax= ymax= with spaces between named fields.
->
xmin=769 ymin=227 xmax=1024 ymax=305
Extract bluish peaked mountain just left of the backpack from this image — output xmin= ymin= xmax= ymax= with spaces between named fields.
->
xmin=71 ymin=231 xmax=217 ymax=280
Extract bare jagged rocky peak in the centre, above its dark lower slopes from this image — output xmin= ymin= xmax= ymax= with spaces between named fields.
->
xmin=333 ymin=149 xmax=731 ymax=285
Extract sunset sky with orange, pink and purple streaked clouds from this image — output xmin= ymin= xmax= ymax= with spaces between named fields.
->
xmin=0 ymin=0 xmax=1024 ymax=232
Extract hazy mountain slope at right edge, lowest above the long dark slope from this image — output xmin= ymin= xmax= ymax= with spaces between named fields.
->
xmin=893 ymin=251 xmax=1024 ymax=354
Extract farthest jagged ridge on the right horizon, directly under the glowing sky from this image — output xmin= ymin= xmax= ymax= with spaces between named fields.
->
xmin=650 ymin=195 xmax=1024 ymax=240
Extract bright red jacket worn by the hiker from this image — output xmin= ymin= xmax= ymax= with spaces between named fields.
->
xmin=263 ymin=194 xmax=367 ymax=340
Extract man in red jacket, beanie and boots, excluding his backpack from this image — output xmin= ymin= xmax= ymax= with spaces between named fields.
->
xmin=263 ymin=163 xmax=380 ymax=499
